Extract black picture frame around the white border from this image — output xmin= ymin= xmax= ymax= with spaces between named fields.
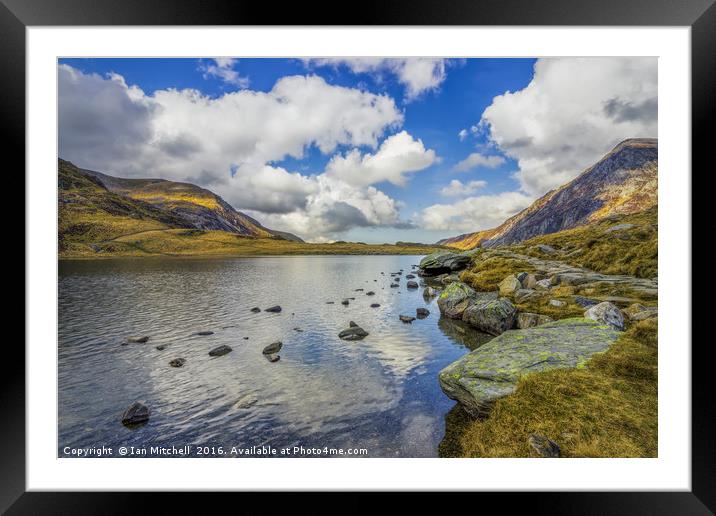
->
xmin=0 ymin=0 xmax=716 ymax=515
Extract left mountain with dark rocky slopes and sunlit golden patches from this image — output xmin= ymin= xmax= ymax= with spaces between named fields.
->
xmin=58 ymin=159 xmax=302 ymax=250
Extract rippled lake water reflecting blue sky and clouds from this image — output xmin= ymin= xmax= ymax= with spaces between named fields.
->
xmin=58 ymin=256 xmax=488 ymax=457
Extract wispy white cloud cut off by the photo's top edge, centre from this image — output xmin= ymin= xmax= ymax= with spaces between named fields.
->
xmin=305 ymin=57 xmax=448 ymax=101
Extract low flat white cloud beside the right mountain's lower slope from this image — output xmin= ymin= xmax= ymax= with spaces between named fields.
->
xmin=420 ymin=192 xmax=533 ymax=233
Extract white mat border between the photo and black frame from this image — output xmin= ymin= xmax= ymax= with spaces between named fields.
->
xmin=26 ymin=27 xmax=691 ymax=491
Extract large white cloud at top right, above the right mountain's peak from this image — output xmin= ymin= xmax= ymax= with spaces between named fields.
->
xmin=478 ymin=57 xmax=658 ymax=196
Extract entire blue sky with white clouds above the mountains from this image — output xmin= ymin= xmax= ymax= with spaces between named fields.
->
xmin=58 ymin=57 xmax=658 ymax=243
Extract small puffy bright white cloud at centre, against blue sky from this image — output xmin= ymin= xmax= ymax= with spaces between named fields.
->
xmin=326 ymin=131 xmax=436 ymax=186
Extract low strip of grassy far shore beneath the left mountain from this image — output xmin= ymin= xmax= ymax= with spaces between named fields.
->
xmin=60 ymin=229 xmax=438 ymax=258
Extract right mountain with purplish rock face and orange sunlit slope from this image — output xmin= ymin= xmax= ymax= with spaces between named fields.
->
xmin=438 ymin=138 xmax=658 ymax=249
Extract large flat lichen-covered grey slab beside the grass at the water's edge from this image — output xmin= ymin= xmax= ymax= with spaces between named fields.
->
xmin=439 ymin=318 xmax=619 ymax=416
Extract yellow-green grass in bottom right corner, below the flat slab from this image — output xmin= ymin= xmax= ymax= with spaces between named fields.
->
xmin=440 ymin=319 xmax=658 ymax=457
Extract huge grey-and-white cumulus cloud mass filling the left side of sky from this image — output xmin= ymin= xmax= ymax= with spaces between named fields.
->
xmin=58 ymin=63 xmax=430 ymax=240
